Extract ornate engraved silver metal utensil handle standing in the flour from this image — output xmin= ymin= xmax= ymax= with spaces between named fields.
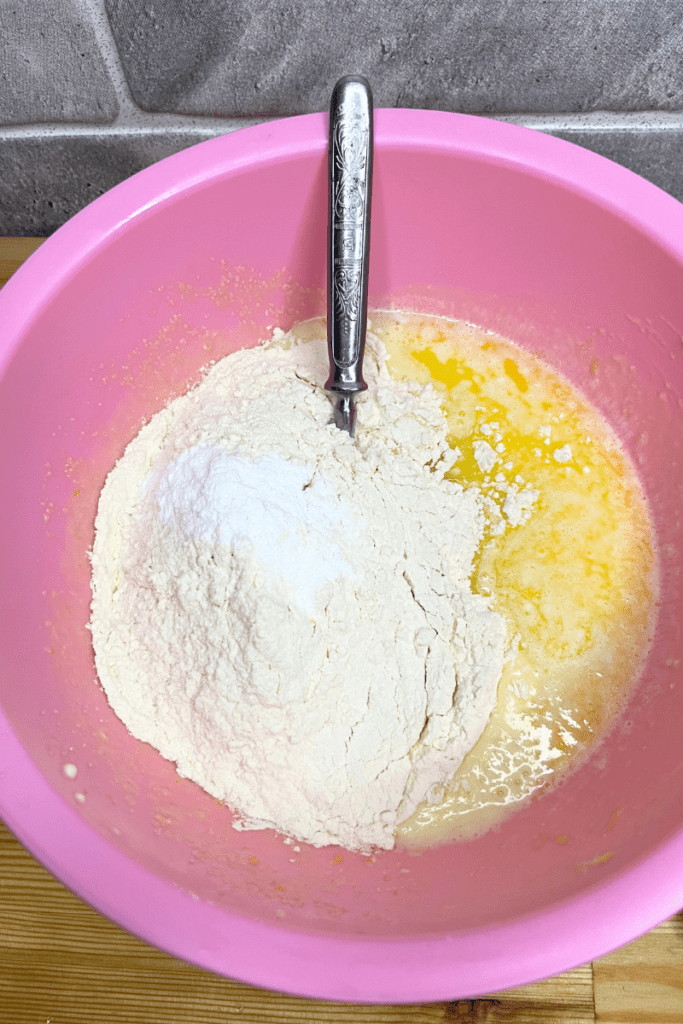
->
xmin=325 ymin=76 xmax=373 ymax=437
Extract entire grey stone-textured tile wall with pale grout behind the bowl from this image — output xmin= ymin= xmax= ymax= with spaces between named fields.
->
xmin=0 ymin=0 xmax=683 ymax=236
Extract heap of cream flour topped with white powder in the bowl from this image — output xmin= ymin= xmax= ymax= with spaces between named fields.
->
xmin=90 ymin=323 xmax=516 ymax=850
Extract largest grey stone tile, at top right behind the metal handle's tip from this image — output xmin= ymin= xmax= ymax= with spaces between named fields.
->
xmin=105 ymin=0 xmax=683 ymax=118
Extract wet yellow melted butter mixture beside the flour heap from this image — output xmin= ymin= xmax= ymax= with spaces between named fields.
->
xmin=373 ymin=312 xmax=656 ymax=846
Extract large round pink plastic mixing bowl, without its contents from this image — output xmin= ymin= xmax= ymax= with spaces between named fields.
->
xmin=0 ymin=111 xmax=683 ymax=1001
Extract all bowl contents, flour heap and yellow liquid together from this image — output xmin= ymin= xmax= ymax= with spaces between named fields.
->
xmin=90 ymin=314 xmax=653 ymax=850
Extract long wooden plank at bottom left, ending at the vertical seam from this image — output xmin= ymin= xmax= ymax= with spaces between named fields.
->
xmin=0 ymin=823 xmax=594 ymax=1024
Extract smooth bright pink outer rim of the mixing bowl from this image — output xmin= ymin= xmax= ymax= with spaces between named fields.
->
xmin=0 ymin=110 xmax=683 ymax=1002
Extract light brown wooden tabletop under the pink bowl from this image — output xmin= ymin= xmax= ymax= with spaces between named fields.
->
xmin=0 ymin=239 xmax=683 ymax=1024
